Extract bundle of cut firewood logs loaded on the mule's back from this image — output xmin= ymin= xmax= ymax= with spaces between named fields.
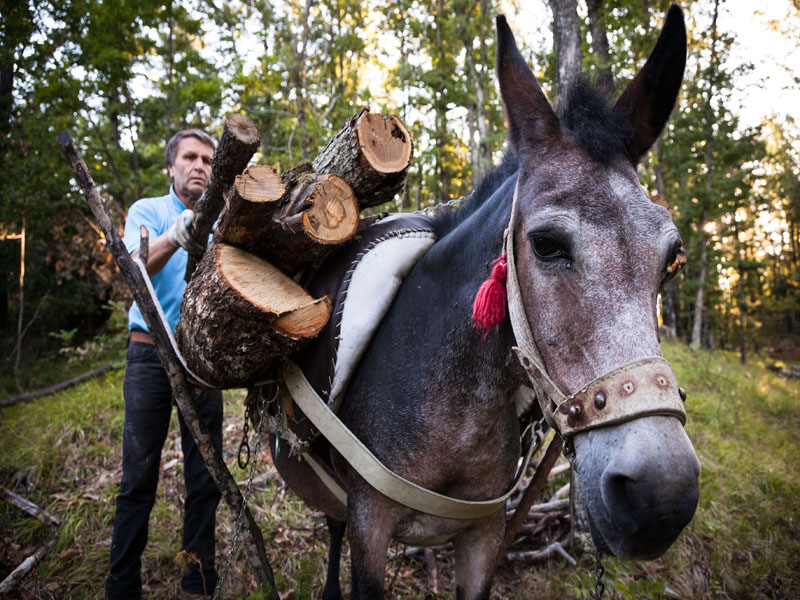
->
xmin=175 ymin=109 xmax=413 ymax=388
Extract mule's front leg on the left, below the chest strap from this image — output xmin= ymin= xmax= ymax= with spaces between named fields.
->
xmin=347 ymin=488 xmax=395 ymax=600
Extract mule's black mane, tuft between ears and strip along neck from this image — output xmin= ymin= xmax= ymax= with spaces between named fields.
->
xmin=433 ymin=76 xmax=631 ymax=239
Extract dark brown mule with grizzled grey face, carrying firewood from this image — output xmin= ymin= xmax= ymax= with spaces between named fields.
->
xmin=274 ymin=5 xmax=700 ymax=600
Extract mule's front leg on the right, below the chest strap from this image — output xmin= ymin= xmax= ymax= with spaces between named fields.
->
xmin=454 ymin=510 xmax=505 ymax=600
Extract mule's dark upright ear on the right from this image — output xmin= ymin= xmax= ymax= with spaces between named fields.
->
xmin=614 ymin=4 xmax=686 ymax=165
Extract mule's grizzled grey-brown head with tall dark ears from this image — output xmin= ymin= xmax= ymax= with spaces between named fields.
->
xmin=497 ymin=6 xmax=700 ymax=558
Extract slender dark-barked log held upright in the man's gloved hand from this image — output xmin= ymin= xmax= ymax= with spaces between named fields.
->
xmin=185 ymin=113 xmax=261 ymax=282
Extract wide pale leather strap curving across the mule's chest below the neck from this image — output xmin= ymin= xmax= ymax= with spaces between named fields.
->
xmin=283 ymin=361 xmax=536 ymax=519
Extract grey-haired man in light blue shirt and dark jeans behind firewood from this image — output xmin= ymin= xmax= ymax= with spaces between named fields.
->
xmin=106 ymin=129 xmax=222 ymax=600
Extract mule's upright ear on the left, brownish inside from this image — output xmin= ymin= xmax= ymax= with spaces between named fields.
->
xmin=496 ymin=15 xmax=560 ymax=154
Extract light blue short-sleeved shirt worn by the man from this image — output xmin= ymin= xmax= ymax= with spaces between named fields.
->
xmin=124 ymin=186 xmax=189 ymax=333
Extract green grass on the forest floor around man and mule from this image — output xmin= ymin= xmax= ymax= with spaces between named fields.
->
xmin=0 ymin=343 xmax=800 ymax=600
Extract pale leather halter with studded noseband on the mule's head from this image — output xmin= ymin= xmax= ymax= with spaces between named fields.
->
xmin=503 ymin=180 xmax=686 ymax=438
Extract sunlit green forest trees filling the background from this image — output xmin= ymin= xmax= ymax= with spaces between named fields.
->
xmin=0 ymin=0 xmax=800 ymax=377
